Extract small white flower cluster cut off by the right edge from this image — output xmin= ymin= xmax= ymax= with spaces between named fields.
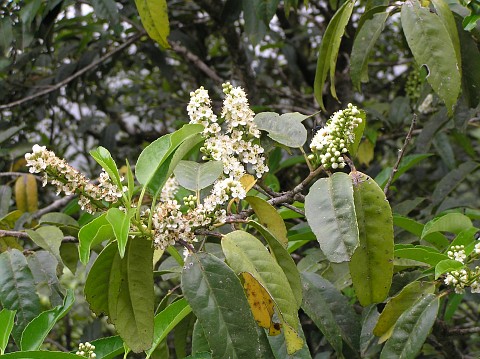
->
xmin=444 ymin=242 xmax=480 ymax=294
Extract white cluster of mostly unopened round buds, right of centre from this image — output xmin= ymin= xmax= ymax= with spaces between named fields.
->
xmin=310 ymin=103 xmax=363 ymax=169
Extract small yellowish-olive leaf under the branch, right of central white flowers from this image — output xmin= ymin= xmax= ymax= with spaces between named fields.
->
xmin=245 ymin=196 xmax=288 ymax=248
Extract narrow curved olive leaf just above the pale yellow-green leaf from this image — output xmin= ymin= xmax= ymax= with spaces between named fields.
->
xmin=248 ymin=221 xmax=302 ymax=308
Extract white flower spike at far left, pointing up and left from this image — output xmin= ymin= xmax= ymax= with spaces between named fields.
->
xmin=25 ymin=145 xmax=126 ymax=213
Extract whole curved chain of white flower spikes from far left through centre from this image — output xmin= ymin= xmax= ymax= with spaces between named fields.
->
xmin=25 ymin=83 xmax=268 ymax=249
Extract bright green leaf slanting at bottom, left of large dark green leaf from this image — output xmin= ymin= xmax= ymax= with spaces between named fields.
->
xmin=146 ymin=298 xmax=192 ymax=358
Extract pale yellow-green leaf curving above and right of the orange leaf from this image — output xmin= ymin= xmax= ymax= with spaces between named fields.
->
xmin=222 ymin=231 xmax=299 ymax=352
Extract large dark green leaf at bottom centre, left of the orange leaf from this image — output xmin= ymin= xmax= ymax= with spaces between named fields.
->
xmin=182 ymin=253 xmax=259 ymax=358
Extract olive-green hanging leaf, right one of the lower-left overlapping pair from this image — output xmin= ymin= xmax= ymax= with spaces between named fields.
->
xmin=108 ymin=237 xmax=154 ymax=353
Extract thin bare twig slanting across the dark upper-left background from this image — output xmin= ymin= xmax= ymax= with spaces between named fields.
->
xmin=0 ymin=33 xmax=144 ymax=110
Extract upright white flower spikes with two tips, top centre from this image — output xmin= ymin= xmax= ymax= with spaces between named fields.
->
xmin=187 ymin=82 xmax=268 ymax=180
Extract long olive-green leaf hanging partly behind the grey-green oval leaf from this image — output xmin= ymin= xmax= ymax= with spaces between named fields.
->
xmin=349 ymin=172 xmax=393 ymax=306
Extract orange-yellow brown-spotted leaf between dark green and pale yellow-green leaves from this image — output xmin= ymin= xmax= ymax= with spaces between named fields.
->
xmin=241 ymin=272 xmax=281 ymax=335
